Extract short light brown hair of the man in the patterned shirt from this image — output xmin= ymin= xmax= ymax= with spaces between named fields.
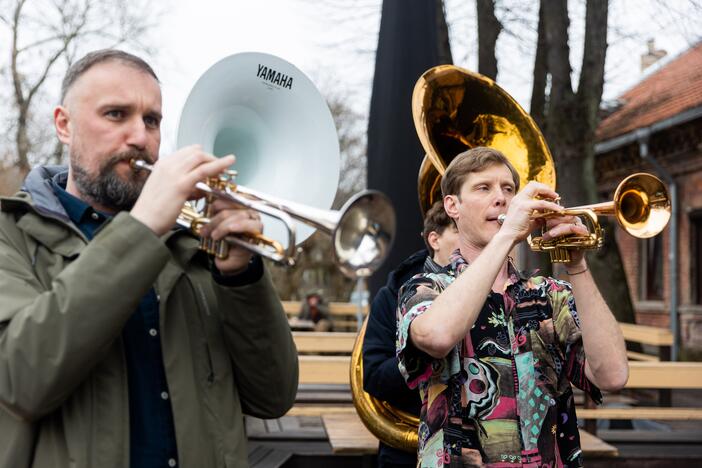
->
xmin=441 ymin=146 xmax=519 ymax=197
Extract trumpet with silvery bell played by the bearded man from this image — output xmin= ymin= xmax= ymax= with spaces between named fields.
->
xmin=130 ymin=159 xmax=395 ymax=278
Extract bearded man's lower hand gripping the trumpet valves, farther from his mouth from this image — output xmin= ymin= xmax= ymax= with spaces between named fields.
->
xmin=200 ymin=199 xmax=263 ymax=275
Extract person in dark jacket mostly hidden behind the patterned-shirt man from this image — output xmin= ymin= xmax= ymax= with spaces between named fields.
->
xmin=363 ymin=201 xmax=458 ymax=468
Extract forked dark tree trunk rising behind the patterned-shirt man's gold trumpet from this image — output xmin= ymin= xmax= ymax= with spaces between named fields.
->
xmin=541 ymin=0 xmax=635 ymax=322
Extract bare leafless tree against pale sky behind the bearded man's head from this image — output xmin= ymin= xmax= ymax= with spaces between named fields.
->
xmin=0 ymin=0 xmax=157 ymax=194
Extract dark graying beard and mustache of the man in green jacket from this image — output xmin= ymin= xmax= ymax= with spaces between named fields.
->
xmin=71 ymin=150 xmax=153 ymax=212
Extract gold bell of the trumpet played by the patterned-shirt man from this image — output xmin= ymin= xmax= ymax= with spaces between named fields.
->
xmin=614 ymin=173 xmax=671 ymax=239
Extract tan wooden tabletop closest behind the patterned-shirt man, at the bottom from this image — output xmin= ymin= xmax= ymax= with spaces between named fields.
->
xmin=322 ymin=413 xmax=619 ymax=458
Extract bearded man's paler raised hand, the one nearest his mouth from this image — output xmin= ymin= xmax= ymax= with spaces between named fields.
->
xmin=131 ymin=145 xmax=235 ymax=236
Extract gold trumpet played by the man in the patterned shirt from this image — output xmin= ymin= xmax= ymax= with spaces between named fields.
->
xmin=527 ymin=172 xmax=671 ymax=263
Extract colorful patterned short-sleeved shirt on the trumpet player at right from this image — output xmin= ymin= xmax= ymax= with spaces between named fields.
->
xmin=397 ymin=250 xmax=601 ymax=468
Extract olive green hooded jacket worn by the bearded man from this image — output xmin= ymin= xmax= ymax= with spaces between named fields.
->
xmin=0 ymin=167 xmax=298 ymax=468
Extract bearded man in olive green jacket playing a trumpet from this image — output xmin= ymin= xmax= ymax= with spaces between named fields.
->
xmin=0 ymin=50 xmax=298 ymax=468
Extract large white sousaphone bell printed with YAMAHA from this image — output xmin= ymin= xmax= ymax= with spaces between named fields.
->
xmin=178 ymin=52 xmax=340 ymax=247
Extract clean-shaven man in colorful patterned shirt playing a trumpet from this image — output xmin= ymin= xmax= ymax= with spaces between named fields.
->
xmin=397 ymin=147 xmax=628 ymax=468
